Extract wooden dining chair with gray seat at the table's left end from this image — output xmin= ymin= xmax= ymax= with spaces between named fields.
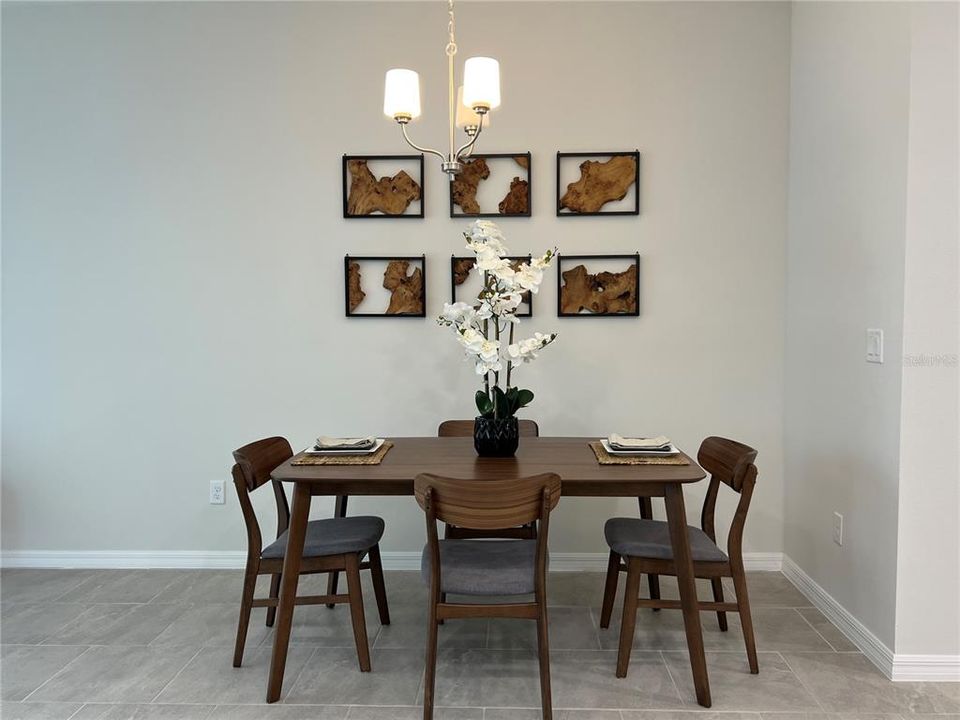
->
xmin=233 ymin=437 xmax=390 ymax=672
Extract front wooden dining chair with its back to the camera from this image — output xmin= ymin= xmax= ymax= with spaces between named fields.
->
xmin=413 ymin=473 xmax=560 ymax=720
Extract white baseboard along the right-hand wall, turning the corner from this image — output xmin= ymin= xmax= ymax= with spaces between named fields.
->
xmin=782 ymin=555 xmax=960 ymax=682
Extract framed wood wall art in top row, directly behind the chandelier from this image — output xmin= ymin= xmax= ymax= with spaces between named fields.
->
xmin=450 ymin=152 xmax=533 ymax=218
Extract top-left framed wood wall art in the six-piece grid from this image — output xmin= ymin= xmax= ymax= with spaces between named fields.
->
xmin=343 ymin=155 xmax=424 ymax=219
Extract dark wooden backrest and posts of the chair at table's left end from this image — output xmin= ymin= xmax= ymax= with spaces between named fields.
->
xmin=233 ymin=437 xmax=293 ymax=559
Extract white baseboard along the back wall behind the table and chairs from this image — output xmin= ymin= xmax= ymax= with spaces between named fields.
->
xmin=0 ymin=550 xmax=783 ymax=572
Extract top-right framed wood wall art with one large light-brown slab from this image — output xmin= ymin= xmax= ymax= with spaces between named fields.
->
xmin=557 ymin=150 xmax=640 ymax=217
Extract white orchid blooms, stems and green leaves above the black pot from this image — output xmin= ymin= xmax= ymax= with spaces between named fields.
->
xmin=437 ymin=220 xmax=557 ymax=418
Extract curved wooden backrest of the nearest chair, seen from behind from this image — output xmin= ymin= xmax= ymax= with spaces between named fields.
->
xmin=413 ymin=473 xmax=560 ymax=530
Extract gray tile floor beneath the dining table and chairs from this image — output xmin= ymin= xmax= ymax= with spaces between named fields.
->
xmin=0 ymin=570 xmax=960 ymax=720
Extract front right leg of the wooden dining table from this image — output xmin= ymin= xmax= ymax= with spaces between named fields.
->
xmin=665 ymin=483 xmax=710 ymax=707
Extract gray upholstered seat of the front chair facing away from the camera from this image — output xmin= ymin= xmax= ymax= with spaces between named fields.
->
xmin=420 ymin=540 xmax=537 ymax=595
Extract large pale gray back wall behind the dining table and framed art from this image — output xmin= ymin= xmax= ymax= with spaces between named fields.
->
xmin=2 ymin=2 xmax=790 ymax=552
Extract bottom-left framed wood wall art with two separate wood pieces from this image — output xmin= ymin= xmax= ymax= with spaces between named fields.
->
xmin=343 ymin=255 xmax=427 ymax=317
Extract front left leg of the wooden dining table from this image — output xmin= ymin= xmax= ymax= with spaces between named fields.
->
xmin=267 ymin=483 xmax=310 ymax=702
